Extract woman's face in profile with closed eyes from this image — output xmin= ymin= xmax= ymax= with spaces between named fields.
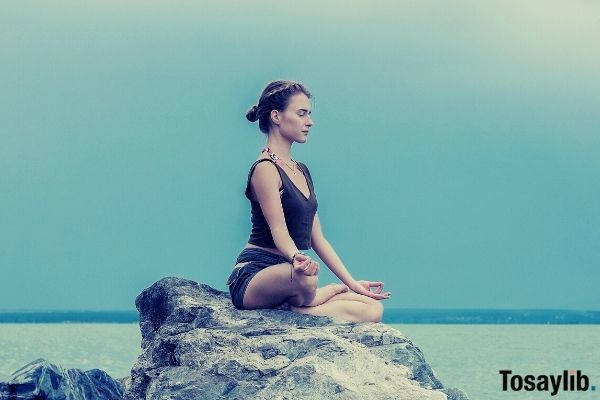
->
xmin=279 ymin=93 xmax=313 ymax=143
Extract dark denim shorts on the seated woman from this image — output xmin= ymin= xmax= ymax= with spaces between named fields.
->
xmin=227 ymin=248 xmax=289 ymax=310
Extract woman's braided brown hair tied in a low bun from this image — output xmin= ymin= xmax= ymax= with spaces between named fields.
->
xmin=246 ymin=80 xmax=311 ymax=133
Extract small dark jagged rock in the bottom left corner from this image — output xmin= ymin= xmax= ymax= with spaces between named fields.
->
xmin=0 ymin=358 xmax=123 ymax=400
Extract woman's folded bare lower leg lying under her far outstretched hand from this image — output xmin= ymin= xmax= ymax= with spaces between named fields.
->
xmin=291 ymin=292 xmax=383 ymax=322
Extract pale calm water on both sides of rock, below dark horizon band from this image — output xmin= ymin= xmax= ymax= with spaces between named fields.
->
xmin=0 ymin=324 xmax=600 ymax=400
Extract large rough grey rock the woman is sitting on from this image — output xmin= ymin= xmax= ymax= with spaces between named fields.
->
xmin=125 ymin=277 xmax=467 ymax=400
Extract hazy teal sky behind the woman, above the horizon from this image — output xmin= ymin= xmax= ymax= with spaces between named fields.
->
xmin=0 ymin=0 xmax=600 ymax=310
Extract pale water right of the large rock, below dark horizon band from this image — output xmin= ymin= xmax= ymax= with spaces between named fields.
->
xmin=390 ymin=324 xmax=600 ymax=400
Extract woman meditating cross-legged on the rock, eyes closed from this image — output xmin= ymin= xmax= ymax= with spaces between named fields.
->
xmin=227 ymin=80 xmax=391 ymax=322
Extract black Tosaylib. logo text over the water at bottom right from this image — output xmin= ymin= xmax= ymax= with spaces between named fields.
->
xmin=499 ymin=369 xmax=596 ymax=396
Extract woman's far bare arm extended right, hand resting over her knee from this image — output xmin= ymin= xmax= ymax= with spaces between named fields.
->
xmin=311 ymin=213 xmax=391 ymax=300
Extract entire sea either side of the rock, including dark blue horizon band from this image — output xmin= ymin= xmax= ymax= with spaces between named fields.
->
xmin=0 ymin=310 xmax=600 ymax=400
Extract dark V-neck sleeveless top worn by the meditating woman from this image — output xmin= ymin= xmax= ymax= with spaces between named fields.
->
xmin=246 ymin=158 xmax=318 ymax=250
